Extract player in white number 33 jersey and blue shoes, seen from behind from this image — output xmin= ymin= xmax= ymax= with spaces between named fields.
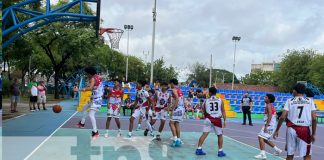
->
xmin=196 ymin=87 xmax=226 ymax=157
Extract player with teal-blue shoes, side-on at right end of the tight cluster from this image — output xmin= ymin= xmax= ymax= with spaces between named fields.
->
xmin=170 ymin=79 xmax=185 ymax=147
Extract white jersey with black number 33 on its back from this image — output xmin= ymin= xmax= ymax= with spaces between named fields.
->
xmin=205 ymin=96 xmax=222 ymax=118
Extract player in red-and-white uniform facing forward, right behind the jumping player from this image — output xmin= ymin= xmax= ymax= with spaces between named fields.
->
xmin=105 ymin=79 xmax=124 ymax=138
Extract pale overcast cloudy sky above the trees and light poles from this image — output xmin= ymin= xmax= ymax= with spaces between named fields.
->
xmin=96 ymin=0 xmax=324 ymax=80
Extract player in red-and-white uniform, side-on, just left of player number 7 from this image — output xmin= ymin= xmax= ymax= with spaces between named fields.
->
xmin=255 ymin=94 xmax=282 ymax=159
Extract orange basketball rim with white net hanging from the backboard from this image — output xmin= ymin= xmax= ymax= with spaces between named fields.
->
xmin=99 ymin=28 xmax=124 ymax=49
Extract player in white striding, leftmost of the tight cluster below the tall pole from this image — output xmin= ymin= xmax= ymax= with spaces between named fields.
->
xmin=128 ymin=81 xmax=151 ymax=137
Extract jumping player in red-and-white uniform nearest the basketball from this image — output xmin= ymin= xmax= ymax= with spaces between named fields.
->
xmin=75 ymin=67 xmax=103 ymax=140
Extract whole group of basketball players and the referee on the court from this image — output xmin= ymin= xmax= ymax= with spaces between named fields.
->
xmin=74 ymin=67 xmax=316 ymax=160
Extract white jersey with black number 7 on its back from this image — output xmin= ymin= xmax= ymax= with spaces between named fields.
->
xmin=284 ymin=97 xmax=316 ymax=126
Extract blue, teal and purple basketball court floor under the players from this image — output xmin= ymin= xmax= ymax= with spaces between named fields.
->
xmin=3 ymin=101 xmax=324 ymax=160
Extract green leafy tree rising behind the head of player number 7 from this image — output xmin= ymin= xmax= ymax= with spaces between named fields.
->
xmin=276 ymin=49 xmax=317 ymax=92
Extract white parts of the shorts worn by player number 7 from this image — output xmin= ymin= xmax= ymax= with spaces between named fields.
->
xmin=286 ymin=127 xmax=312 ymax=157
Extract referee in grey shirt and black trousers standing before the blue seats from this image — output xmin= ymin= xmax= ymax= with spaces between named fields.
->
xmin=241 ymin=93 xmax=253 ymax=126
